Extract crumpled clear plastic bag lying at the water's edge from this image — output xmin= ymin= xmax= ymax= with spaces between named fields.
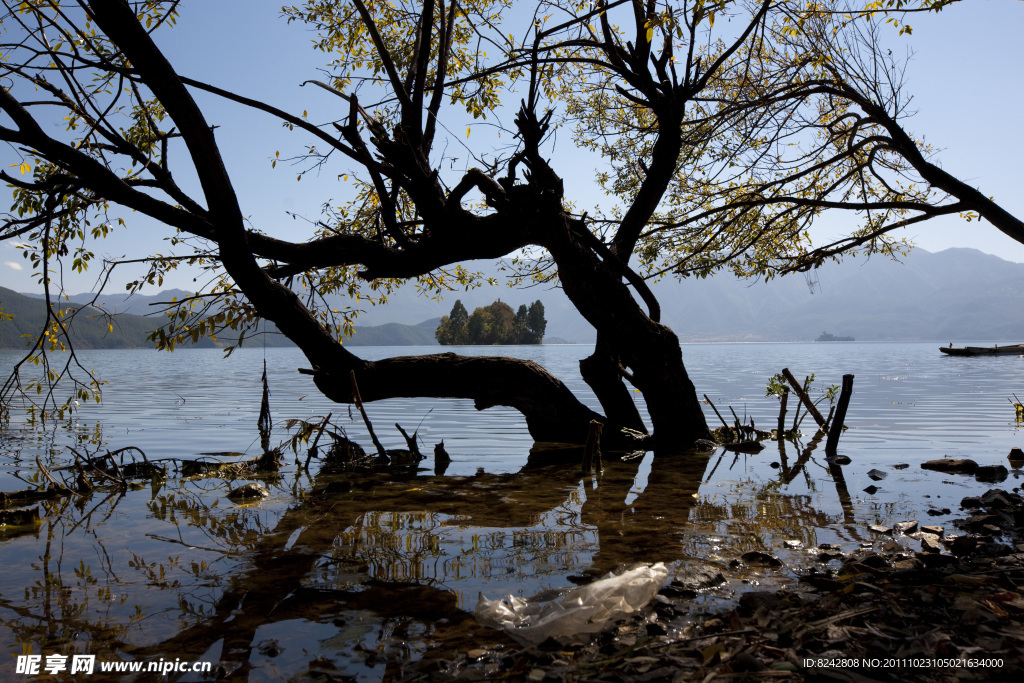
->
xmin=476 ymin=562 xmax=669 ymax=644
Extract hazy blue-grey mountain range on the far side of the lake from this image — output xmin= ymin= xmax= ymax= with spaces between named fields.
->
xmin=12 ymin=249 xmax=1024 ymax=347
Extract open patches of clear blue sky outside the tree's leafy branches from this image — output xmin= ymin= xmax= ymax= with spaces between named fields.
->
xmin=0 ymin=0 xmax=1024 ymax=292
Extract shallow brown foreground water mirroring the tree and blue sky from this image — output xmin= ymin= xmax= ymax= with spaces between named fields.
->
xmin=0 ymin=419 xmax=1015 ymax=679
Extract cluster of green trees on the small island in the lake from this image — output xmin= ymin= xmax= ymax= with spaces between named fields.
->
xmin=434 ymin=300 xmax=548 ymax=346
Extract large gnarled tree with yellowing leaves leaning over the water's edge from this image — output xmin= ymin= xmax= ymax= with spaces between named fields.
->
xmin=0 ymin=0 xmax=1024 ymax=453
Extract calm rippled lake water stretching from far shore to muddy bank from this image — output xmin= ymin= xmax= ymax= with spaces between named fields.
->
xmin=0 ymin=342 xmax=1024 ymax=680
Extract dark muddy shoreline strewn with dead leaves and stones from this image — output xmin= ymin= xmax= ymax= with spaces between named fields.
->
xmin=397 ymin=488 xmax=1024 ymax=683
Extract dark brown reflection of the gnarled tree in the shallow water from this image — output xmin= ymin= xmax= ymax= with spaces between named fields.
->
xmin=0 ymin=444 xmax=868 ymax=676
